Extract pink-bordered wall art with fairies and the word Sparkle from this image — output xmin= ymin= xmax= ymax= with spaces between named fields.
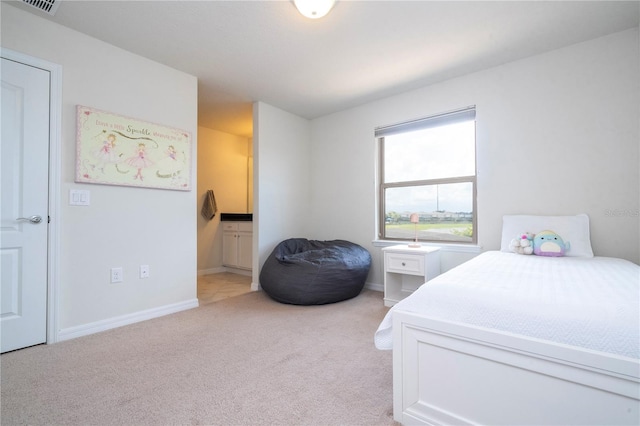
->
xmin=76 ymin=105 xmax=191 ymax=191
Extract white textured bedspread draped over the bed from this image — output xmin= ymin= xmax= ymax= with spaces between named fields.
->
xmin=374 ymin=251 xmax=640 ymax=359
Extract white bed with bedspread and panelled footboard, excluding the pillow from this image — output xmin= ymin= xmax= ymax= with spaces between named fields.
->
xmin=374 ymin=216 xmax=640 ymax=425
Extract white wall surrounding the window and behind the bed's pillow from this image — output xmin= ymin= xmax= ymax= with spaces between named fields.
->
xmin=309 ymin=29 xmax=640 ymax=284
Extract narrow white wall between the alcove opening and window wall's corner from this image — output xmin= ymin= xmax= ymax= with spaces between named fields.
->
xmin=253 ymin=102 xmax=315 ymax=287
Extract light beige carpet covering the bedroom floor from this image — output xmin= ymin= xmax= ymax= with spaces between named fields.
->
xmin=0 ymin=290 xmax=395 ymax=426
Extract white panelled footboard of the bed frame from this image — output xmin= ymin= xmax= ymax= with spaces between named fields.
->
xmin=393 ymin=311 xmax=640 ymax=426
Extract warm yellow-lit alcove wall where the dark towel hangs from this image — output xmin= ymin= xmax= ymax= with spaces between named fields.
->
xmin=197 ymin=127 xmax=251 ymax=274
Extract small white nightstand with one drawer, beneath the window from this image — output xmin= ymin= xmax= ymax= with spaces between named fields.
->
xmin=382 ymin=245 xmax=440 ymax=306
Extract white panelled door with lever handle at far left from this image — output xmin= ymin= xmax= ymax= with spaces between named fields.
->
xmin=0 ymin=58 xmax=50 ymax=352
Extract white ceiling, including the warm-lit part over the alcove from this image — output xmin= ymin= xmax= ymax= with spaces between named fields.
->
xmin=11 ymin=0 xmax=640 ymax=136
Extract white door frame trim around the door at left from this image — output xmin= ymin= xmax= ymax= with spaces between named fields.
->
xmin=0 ymin=47 xmax=62 ymax=343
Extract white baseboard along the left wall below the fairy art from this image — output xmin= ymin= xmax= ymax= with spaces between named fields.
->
xmin=57 ymin=299 xmax=199 ymax=342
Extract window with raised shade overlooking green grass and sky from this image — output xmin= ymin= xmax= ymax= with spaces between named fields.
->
xmin=375 ymin=107 xmax=477 ymax=243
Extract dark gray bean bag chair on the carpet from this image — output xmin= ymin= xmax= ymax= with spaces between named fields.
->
xmin=260 ymin=238 xmax=371 ymax=305
